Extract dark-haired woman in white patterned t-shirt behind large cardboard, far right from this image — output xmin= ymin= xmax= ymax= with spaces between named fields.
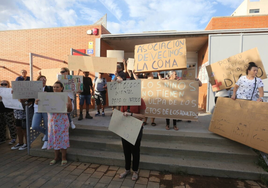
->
xmin=231 ymin=62 xmax=264 ymax=102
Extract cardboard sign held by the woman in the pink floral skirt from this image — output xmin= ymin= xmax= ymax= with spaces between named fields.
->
xmin=38 ymin=92 xmax=68 ymax=113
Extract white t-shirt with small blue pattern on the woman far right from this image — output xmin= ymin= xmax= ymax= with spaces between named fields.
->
xmin=236 ymin=76 xmax=263 ymax=101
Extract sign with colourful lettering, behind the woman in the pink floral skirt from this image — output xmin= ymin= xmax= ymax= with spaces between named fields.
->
xmin=58 ymin=75 xmax=83 ymax=92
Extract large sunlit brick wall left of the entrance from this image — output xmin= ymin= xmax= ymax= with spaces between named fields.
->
xmin=0 ymin=25 xmax=108 ymax=81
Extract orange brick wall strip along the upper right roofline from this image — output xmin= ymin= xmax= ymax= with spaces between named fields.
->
xmin=205 ymin=15 xmax=268 ymax=30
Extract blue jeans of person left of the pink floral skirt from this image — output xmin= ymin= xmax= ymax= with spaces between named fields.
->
xmin=32 ymin=112 xmax=48 ymax=141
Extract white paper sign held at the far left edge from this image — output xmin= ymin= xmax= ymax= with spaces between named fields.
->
xmin=0 ymin=88 xmax=23 ymax=110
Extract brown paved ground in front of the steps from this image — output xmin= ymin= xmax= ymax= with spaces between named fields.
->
xmin=0 ymin=140 xmax=265 ymax=188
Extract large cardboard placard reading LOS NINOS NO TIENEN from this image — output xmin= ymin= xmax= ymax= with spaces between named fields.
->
xmin=141 ymin=79 xmax=199 ymax=121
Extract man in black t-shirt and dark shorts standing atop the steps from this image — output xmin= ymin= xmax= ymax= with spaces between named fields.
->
xmin=78 ymin=69 xmax=94 ymax=121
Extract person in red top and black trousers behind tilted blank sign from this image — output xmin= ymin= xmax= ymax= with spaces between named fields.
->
xmin=119 ymin=99 xmax=146 ymax=181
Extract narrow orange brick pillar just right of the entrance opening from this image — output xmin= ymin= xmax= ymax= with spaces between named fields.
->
xmin=198 ymin=42 xmax=208 ymax=109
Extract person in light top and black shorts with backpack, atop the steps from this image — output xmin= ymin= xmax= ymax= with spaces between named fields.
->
xmin=93 ymin=73 xmax=107 ymax=116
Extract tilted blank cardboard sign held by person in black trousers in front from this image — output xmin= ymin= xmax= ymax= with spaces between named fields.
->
xmin=108 ymin=109 xmax=143 ymax=145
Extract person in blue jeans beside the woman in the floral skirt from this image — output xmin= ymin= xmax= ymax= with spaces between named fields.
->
xmin=32 ymin=75 xmax=53 ymax=149
